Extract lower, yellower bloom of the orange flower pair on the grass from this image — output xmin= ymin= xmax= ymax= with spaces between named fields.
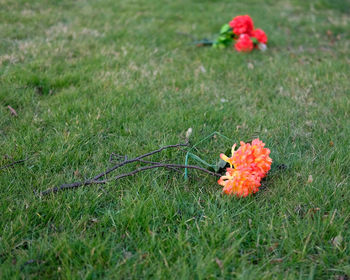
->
xmin=218 ymin=168 xmax=261 ymax=197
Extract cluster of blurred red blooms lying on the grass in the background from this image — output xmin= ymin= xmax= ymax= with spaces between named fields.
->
xmin=229 ymin=15 xmax=267 ymax=52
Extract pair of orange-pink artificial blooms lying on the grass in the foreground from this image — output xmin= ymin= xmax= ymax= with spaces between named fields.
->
xmin=218 ymin=139 xmax=272 ymax=197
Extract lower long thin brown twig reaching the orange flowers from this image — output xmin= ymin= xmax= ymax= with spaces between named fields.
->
xmin=40 ymin=163 xmax=221 ymax=195
